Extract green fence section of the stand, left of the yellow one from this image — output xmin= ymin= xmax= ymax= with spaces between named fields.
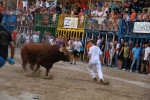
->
xmin=34 ymin=14 xmax=58 ymax=36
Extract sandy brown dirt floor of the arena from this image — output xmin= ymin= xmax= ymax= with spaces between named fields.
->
xmin=0 ymin=50 xmax=150 ymax=100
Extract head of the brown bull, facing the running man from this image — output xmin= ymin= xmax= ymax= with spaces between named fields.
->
xmin=59 ymin=47 xmax=70 ymax=62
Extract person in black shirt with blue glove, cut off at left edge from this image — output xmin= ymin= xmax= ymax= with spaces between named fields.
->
xmin=0 ymin=14 xmax=15 ymax=68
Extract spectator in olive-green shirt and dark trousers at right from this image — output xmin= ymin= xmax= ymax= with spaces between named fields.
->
xmin=123 ymin=42 xmax=129 ymax=70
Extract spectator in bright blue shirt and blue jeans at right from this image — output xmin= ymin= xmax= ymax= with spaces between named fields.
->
xmin=130 ymin=43 xmax=140 ymax=72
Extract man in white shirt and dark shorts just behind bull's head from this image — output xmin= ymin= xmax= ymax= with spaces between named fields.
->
xmin=70 ymin=38 xmax=82 ymax=65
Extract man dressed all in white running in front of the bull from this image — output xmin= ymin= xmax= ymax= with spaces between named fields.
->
xmin=87 ymin=40 xmax=109 ymax=85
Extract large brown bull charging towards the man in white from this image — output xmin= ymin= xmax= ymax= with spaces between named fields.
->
xmin=21 ymin=44 xmax=70 ymax=78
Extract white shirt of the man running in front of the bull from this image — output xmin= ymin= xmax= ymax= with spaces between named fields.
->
xmin=88 ymin=46 xmax=102 ymax=61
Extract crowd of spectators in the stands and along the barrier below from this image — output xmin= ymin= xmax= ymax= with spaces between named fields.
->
xmin=3 ymin=0 xmax=150 ymax=76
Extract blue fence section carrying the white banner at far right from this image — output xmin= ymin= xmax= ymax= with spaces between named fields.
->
xmin=118 ymin=20 xmax=150 ymax=44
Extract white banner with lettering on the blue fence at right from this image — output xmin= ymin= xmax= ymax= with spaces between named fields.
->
xmin=133 ymin=22 xmax=150 ymax=33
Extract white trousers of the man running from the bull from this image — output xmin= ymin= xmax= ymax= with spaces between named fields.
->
xmin=87 ymin=60 xmax=104 ymax=80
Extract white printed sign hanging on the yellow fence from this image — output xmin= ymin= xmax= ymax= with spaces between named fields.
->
xmin=64 ymin=17 xmax=78 ymax=28
